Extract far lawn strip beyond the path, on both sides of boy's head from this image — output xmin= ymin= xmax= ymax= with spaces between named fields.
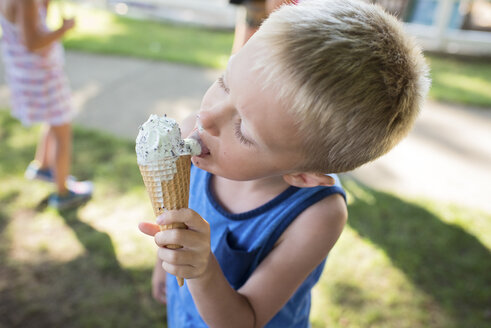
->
xmin=45 ymin=2 xmax=491 ymax=108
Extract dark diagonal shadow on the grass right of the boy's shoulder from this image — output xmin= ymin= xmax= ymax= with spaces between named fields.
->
xmin=345 ymin=178 xmax=491 ymax=327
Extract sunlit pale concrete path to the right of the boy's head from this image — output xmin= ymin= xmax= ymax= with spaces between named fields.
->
xmin=352 ymin=101 xmax=491 ymax=213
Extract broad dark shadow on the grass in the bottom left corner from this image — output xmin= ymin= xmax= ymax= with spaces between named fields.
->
xmin=0 ymin=210 xmax=165 ymax=328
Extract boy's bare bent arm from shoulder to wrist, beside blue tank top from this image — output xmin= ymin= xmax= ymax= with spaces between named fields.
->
xmin=187 ymin=195 xmax=347 ymax=327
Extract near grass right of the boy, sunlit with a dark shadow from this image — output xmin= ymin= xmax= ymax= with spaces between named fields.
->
xmin=312 ymin=179 xmax=491 ymax=328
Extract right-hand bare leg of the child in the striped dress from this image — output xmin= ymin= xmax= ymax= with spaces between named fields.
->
xmin=50 ymin=123 xmax=72 ymax=195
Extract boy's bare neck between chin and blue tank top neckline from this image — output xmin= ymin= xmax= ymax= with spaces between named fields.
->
xmin=210 ymin=175 xmax=290 ymax=214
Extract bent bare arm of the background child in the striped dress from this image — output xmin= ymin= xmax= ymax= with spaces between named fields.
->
xmin=16 ymin=0 xmax=75 ymax=51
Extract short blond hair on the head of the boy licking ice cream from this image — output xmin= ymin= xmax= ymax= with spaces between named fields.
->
xmin=255 ymin=0 xmax=430 ymax=173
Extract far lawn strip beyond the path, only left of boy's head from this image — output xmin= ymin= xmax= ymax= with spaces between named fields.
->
xmin=48 ymin=2 xmax=233 ymax=68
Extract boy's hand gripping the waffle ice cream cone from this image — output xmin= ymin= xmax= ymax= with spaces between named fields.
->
xmin=139 ymin=208 xmax=211 ymax=279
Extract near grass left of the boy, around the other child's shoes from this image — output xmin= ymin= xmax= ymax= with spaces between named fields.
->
xmin=0 ymin=110 xmax=165 ymax=328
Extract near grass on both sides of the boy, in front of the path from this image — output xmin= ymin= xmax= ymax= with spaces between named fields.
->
xmin=0 ymin=110 xmax=491 ymax=328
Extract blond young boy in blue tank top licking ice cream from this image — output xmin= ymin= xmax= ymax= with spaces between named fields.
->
xmin=140 ymin=0 xmax=429 ymax=328
